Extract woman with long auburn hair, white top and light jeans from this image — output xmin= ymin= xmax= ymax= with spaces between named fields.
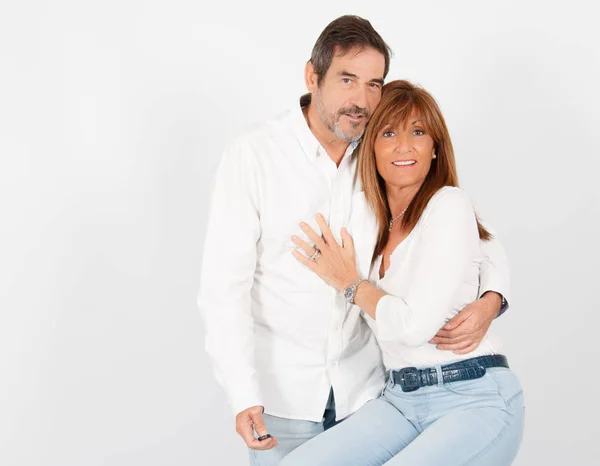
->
xmin=281 ymin=81 xmax=524 ymax=466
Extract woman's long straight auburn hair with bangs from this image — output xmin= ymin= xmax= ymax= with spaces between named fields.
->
xmin=358 ymin=80 xmax=492 ymax=258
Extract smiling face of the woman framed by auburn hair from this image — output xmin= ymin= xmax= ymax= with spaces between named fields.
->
xmin=375 ymin=113 xmax=434 ymax=189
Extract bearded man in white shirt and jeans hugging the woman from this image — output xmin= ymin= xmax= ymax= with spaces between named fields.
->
xmin=199 ymin=16 xmax=508 ymax=466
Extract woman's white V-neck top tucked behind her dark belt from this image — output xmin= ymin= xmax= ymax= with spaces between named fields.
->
xmin=358 ymin=186 xmax=501 ymax=370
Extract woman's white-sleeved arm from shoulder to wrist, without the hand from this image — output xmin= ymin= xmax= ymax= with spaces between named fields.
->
xmin=355 ymin=189 xmax=480 ymax=346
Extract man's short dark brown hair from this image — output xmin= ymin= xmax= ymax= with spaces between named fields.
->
xmin=310 ymin=15 xmax=392 ymax=85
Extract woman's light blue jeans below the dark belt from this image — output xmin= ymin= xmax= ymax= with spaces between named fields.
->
xmin=280 ymin=366 xmax=524 ymax=466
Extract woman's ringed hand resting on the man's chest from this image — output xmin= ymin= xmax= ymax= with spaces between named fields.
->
xmin=292 ymin=214 xmax=360 ymax=291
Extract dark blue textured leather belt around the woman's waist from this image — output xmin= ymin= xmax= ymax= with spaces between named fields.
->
xmin=390 ymin=354 xmax=508 ymax=392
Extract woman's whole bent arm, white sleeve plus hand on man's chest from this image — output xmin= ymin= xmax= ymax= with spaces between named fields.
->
xmin=293 ymin=188 xmax=481 ymax=346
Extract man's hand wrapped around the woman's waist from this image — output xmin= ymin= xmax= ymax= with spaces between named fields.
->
xmin=429 ymin=291 xmax=502 ymax=354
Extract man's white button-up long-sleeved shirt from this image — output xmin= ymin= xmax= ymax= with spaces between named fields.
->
xmin=199 ymin=98 xmax=507 ymax=422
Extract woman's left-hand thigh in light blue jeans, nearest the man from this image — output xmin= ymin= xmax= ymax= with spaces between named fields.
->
xmin=280 ymin=398 xmax=418 ymax=466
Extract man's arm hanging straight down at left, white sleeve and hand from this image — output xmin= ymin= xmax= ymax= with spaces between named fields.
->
xmin=198 ymin=141 xmax=276 ymax=449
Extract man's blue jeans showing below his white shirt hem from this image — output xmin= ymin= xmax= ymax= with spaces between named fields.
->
xmin=249 ymin=390 xmax=337 ymax=466
